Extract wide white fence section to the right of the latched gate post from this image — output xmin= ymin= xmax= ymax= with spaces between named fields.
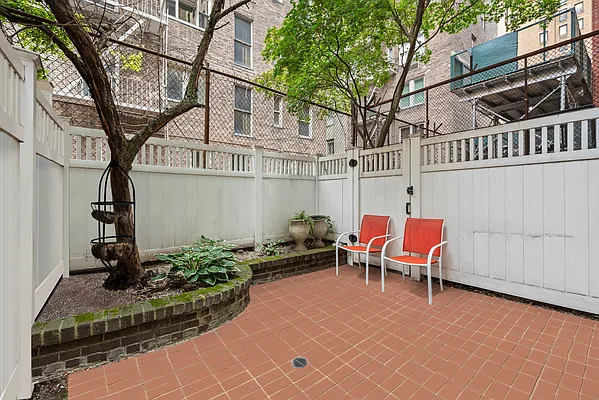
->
xmin=415 ymin=109 xmax=599 ymax=313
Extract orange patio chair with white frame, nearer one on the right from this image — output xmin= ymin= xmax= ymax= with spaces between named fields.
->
xmin=381 ymin=218 xmax=447 ymax=304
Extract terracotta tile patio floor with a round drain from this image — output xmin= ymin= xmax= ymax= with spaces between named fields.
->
xmin=69 ymin=267 xmax=599 ymax=400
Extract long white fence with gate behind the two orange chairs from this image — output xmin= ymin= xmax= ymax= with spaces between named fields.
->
xmin=317 ymin=109 xmax=599 ymax=313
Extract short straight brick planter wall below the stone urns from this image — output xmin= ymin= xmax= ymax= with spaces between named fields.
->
xmin=241 ymin=246 xmax=347 ymax=285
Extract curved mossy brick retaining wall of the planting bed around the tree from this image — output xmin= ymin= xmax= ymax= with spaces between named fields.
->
xmin=31 ymin=263 xmax=252 ymax=381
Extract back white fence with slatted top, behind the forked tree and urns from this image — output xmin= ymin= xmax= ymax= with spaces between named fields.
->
xmin=69 ymin=128 xmax=317 ymax=270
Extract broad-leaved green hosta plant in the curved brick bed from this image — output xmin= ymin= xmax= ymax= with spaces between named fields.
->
xmin=152 ymin=235 xmax=239 ymax=286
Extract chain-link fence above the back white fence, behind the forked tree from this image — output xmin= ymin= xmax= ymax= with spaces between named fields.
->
xmin=44 ymin=39 xmax=352 ymax=155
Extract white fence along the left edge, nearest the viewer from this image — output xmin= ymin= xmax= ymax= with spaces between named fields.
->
xmin=0 ymin=35 xmax=68 ymax=400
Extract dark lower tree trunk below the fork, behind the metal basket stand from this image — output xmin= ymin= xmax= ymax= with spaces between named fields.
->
xmin=104 ymin=161 xmax=146 ymax=290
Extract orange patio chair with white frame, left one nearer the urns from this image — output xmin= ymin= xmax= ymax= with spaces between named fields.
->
xmin=335 ymin=214 xmax=391 ymax=285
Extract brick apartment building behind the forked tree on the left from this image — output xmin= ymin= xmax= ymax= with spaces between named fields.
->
xmin=46 ymin=0 xmax=338 ymax=154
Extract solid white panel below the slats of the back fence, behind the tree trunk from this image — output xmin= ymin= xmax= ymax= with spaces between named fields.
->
xmin=70 ymin=163 xmax=258 ymax=269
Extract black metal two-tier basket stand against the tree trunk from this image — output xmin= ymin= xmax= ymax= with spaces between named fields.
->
xmin=91 ymin=161 xmax=135 ymax=271
